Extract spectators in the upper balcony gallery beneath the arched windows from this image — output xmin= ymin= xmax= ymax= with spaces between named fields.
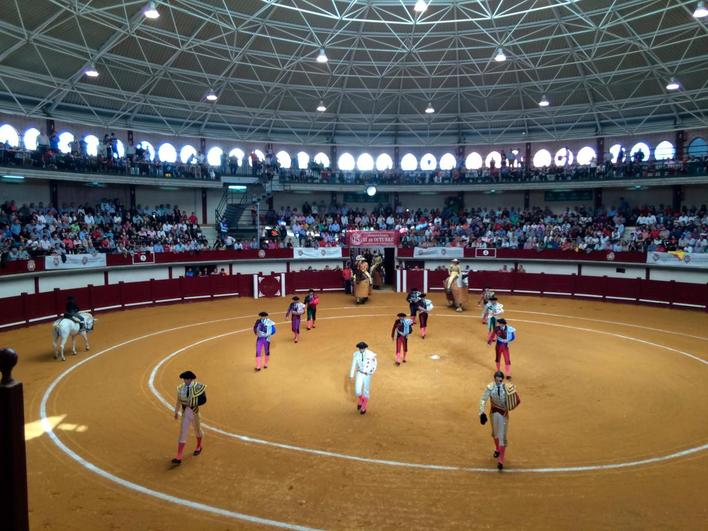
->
xmin=0 ymin=133 xmax=708 ymax=185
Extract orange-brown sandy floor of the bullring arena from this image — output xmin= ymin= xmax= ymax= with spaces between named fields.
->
xmin=6 ymin=293 xmax=708 ymax=531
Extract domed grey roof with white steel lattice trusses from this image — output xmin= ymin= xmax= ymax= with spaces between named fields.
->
xmin=0 ymin=0 xmax=708 ymax=145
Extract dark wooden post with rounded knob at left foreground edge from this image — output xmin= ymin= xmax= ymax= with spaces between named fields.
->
xmin=0 ymin=348 xmax=29 ymax=531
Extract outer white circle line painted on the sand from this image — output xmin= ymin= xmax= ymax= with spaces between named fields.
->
xmin=39 ymin=315 xmax=322 ymax=531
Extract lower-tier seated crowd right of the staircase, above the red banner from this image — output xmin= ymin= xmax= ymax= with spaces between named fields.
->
xmin=253 ymin=198 xmax=708 ymax=253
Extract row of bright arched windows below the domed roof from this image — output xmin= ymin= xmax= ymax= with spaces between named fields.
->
xmin=0 ymin=124 xmax=708 ymax=172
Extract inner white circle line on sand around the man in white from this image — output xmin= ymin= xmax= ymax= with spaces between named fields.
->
xmin=148 ymin=314 xmax=708 ymax=474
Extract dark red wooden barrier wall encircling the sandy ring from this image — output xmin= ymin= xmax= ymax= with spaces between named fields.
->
xmin=0 ymin=270 xmax=708 ymax=327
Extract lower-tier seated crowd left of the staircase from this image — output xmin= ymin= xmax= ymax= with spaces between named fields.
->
xmin=0 ymin=199 xmax=208 ymax=261
